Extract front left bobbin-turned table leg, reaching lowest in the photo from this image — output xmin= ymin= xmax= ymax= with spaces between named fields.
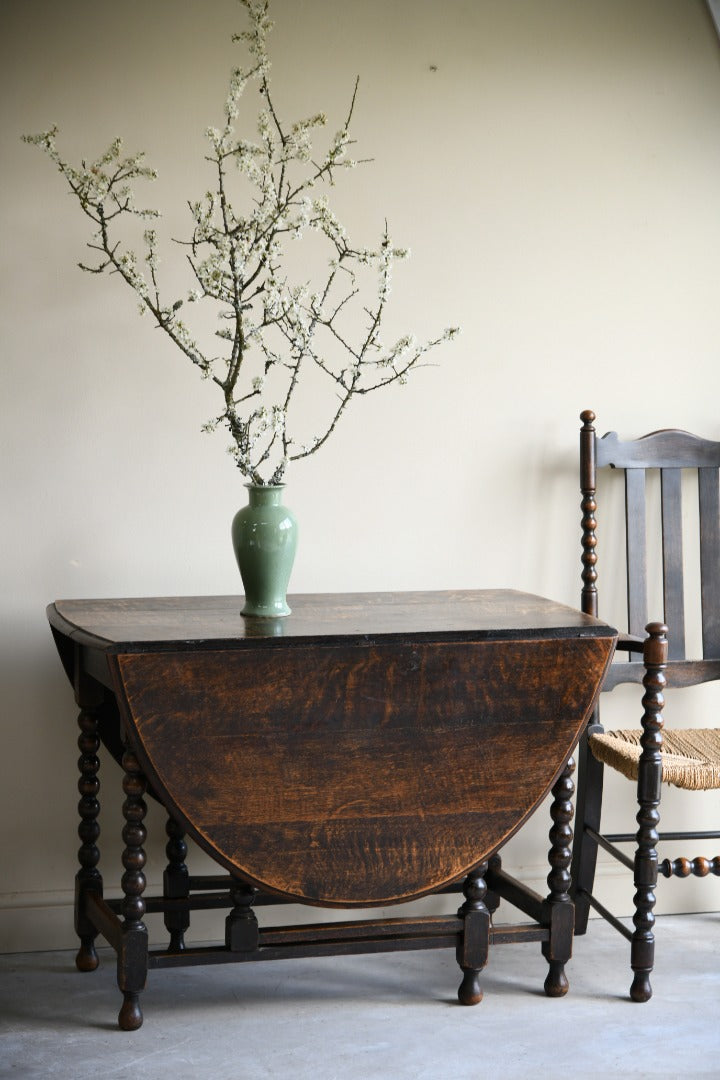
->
xmin=118 ymin=747 xmax=148 ymax=1031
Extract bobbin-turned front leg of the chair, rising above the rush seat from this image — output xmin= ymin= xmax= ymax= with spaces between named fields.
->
xmin=630 ymin=622 xmax=667 ymax=1001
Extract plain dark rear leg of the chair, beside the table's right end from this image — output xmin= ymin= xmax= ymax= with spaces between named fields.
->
xmin=570 ymin=714 xmax=604 ymax=934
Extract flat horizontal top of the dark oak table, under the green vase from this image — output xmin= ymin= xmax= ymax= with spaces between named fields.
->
xmin=47 ymin=589 xmax=614 ymax=652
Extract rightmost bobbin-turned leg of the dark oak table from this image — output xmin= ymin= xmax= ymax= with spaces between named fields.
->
xmin=542 ymin=758 xmax=575 ymax=998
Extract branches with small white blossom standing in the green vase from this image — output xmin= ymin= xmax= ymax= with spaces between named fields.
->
xmin=24 ymin=0 xmax=458 ymax=484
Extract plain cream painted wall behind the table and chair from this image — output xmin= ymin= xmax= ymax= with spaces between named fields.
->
xmin=0 ymin=0 xmax=720 ymax=950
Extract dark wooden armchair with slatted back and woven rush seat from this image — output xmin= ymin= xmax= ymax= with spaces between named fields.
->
xmin=572 ymin=410 xmax=720 ymax=1001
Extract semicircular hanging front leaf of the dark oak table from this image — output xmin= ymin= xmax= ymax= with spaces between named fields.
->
xmin=113 ymin=636 xmax=612 ymax=906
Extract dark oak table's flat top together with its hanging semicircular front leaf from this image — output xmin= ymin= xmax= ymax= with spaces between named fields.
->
xmin=49 ymin=590 xmax=615 ymax=906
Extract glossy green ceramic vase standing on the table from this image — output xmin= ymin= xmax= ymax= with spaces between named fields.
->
xmin=232 ymin=484 xmax=298 ymax=618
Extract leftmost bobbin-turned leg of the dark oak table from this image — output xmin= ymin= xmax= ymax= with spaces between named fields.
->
xmin=74 ymin=676 xmax=103 ymax=971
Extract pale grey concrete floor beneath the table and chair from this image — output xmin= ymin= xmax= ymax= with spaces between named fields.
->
xmin=0 ymin=915 xmax=720 ymax=1080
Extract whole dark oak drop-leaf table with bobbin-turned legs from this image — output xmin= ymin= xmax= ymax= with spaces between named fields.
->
xmin=47 ymin=590 xmax=616 ymax=1030
